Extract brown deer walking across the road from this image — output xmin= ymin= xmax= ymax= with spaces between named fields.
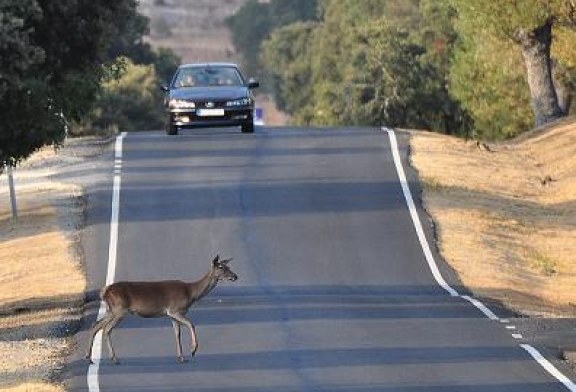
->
xmin=85 ymin=255 xmax=238 ymax=365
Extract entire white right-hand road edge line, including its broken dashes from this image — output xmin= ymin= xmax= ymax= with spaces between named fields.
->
xmin=382 ymin=127 xmax=576 ymax=392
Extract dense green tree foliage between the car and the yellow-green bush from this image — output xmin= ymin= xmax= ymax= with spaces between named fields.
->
xmin=263 ymin=0 xmax=470 ymax=134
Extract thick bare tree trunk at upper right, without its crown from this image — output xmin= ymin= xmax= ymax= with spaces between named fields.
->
xmin=518 ymin=21 xmax=563 ymax=126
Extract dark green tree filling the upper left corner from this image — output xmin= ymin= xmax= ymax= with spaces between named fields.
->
xmin=0 ymin=0 xmax=137 ymax=168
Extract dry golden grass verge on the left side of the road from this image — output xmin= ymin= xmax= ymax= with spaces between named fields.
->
xmin=0 ymin=151 xmax=85 ymax=392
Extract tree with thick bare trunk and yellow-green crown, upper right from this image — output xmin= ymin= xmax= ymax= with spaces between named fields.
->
xmin=452 ymin=0 xmax=576 ymax=126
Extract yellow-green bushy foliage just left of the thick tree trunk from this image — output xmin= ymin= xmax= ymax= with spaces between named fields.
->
xmin=450 ymin=19 xmax=534 ymax=140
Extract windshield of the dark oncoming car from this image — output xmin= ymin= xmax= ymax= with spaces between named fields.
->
xmin=173 ymin=67 xmax=244 ymax=88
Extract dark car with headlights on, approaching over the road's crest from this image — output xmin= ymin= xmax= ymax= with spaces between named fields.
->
xmin=162 ymin=63 xmax=260 ymax=135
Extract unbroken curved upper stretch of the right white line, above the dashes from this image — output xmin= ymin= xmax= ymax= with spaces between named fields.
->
xmin=383 ymin=128 xmax=459 ymax=297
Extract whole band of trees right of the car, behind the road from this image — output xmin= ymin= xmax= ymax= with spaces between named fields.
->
xmin=228 ymin=0 xmax=576 ymax=139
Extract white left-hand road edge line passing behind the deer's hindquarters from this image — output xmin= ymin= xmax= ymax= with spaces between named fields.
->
xmin=86 ymin=132 xmax=126 ymax=392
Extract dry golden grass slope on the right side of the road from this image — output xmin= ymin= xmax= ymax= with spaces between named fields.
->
xmin=412 ymin=119 xmax=576 ymax=314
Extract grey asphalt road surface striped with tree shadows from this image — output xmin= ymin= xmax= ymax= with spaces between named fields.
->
xmin=69 ymin=128 xmax=568 ymax=392
